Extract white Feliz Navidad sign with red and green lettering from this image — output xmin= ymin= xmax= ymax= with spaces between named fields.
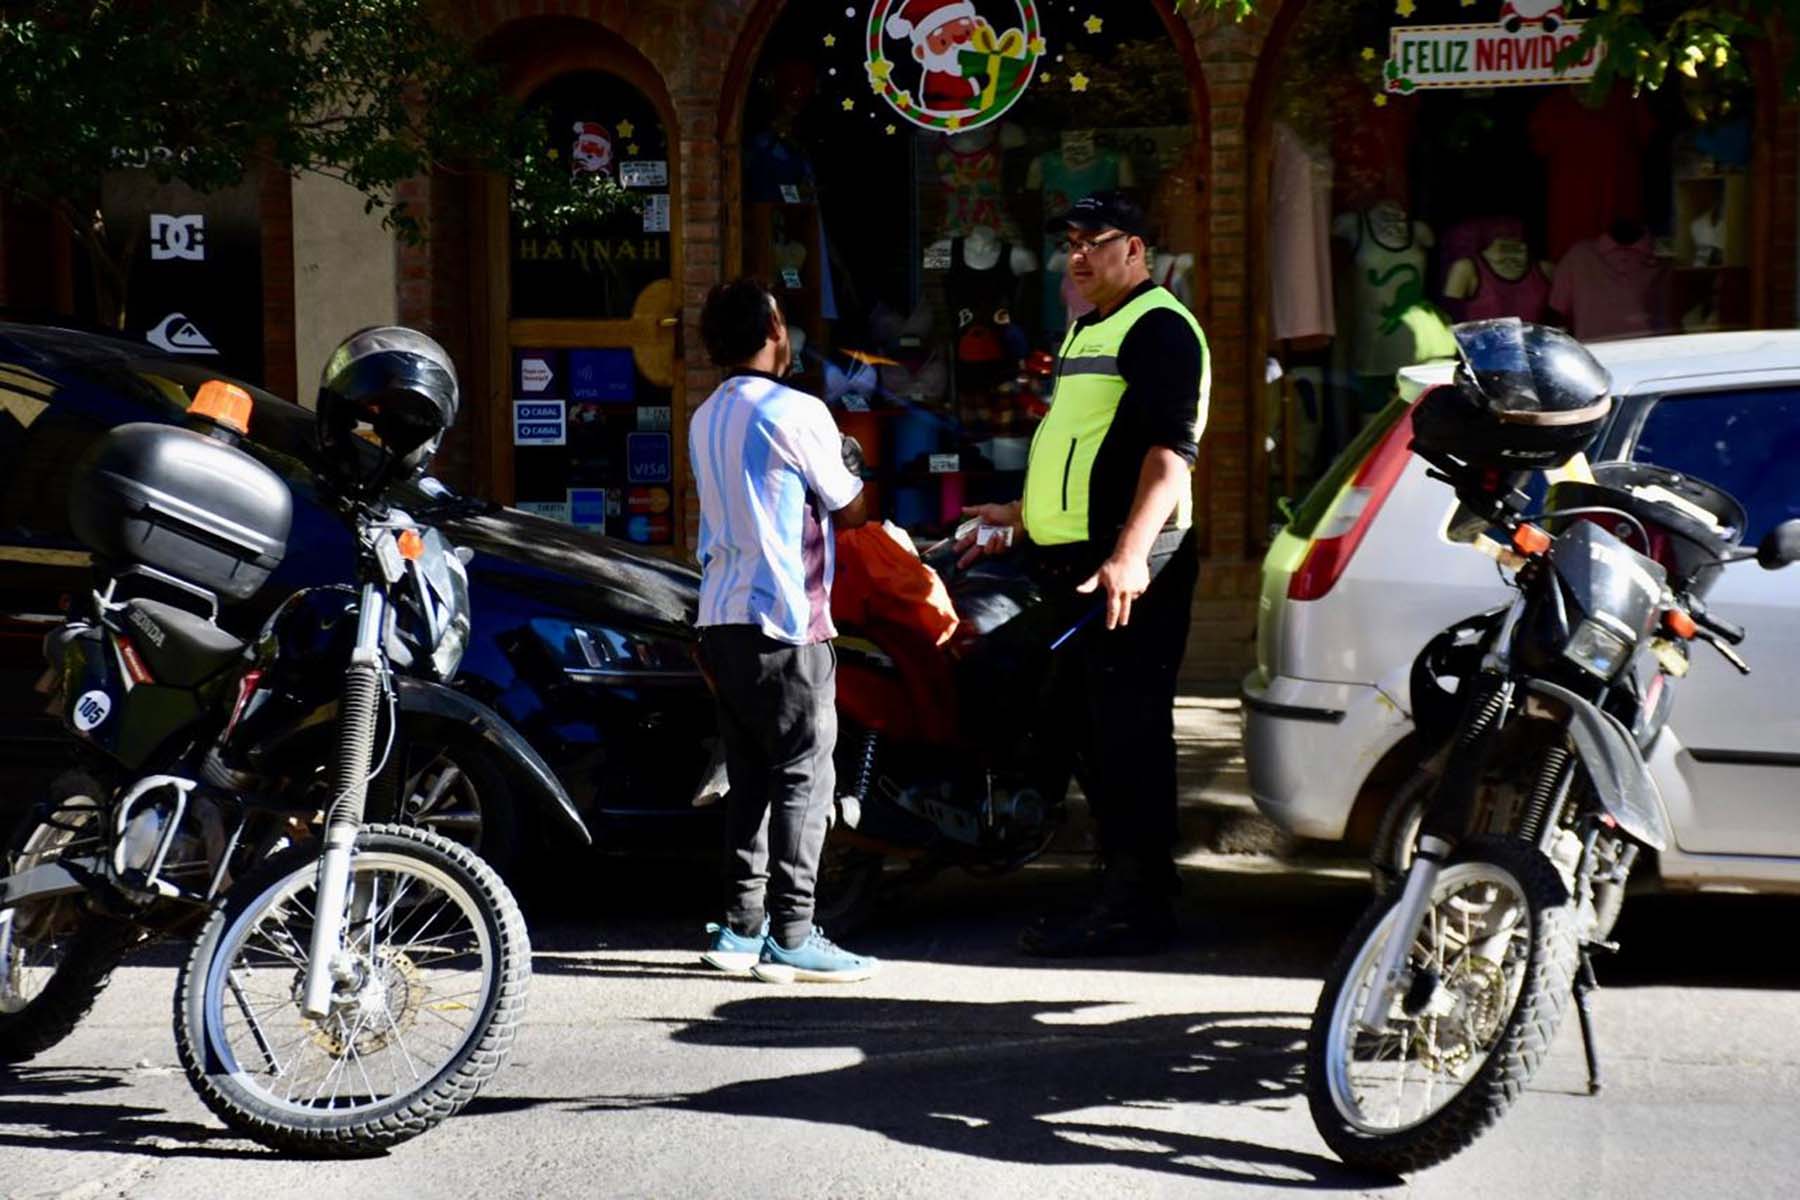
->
xmin=1381 ymin=0 xmax=1600 ymax=95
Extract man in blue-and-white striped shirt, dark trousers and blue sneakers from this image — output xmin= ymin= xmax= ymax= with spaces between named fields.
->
xmin=688 ymin=279 xmax=877 ymax=982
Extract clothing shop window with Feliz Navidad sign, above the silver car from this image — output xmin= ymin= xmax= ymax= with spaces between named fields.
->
xmin=1264 ymin=0 xmax=1753 ymax=536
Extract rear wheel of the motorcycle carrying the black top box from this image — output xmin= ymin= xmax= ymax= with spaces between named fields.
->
xmin=0 ymin=774 xmax=137 ymax=1063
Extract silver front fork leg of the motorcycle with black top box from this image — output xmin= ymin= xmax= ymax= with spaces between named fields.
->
xmin=301 ymin=583 xmax=387 ymax=1020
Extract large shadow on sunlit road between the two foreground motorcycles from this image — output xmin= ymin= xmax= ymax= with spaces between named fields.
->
xmin=472 ymin=995 xmax=1399 ymax=1189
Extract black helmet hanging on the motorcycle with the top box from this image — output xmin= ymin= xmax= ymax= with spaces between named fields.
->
xmin=317 ymin=326 xmax=457 ymax=491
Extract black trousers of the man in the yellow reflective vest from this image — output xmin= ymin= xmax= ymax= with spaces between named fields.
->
xmin=1046 ymin=531 xmax=1201 ymax=905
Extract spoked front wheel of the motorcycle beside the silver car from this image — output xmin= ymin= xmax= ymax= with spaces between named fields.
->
xmin=1307 ymin=837 xmax=1580 ymax=1175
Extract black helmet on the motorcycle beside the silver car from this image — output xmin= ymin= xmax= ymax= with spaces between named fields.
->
xmin=1413 ymin=317 xmax=1613 ymax=471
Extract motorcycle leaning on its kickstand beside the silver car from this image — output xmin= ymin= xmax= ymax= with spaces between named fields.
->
xmin=1307 ymin=389 xmax=1800 ymax=1173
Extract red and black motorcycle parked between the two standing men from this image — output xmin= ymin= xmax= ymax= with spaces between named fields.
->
xmin=815 ymin=531 xmax=1130 ymax=932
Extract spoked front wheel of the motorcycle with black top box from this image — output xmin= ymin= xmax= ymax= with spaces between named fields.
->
xmin=175 ymin=826 xmax=531 ymax=1157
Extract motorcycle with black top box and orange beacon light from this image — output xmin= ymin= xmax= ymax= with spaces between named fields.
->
xmin=0 ymin=352 xmax=585 ymax=1155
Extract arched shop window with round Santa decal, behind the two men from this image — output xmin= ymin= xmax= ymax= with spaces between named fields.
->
xmin=742 ymin=0 xmax=1201 ymax=531
